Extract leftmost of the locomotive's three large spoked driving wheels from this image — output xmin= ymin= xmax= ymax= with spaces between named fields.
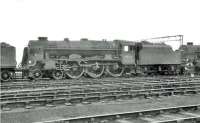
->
xmin=65 ymin=62 xmax=84 ymax=79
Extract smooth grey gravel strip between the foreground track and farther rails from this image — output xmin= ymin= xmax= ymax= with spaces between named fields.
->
xmin=1 ymin=95 xmax=200 ymax=123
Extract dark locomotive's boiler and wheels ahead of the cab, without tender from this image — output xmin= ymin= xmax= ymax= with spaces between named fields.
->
xmin=22 ymin=37 xmax=123 ymax=79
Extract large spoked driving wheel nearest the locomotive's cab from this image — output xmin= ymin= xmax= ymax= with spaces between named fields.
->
xmin=106 ymin=63 xmax=124 ymax=77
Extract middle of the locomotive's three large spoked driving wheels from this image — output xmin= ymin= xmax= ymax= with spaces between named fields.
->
xmin=86 ymin=62 xmax=104 ymax=78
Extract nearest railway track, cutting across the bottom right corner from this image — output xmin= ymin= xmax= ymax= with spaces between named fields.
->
xmin=34 ymin=104 xmax=200 ymax=123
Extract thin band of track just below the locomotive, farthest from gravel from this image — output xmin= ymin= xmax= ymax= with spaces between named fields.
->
xmin=1 ymin=77 xmax=200 ymax=91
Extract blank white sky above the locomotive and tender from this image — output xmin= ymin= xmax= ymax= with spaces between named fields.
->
xmin=0 ymin=0 xmax=200 ymax=63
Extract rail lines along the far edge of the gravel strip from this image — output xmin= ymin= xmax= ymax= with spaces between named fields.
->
xmin=0 ymin=81 xmax=200 ymax=110
